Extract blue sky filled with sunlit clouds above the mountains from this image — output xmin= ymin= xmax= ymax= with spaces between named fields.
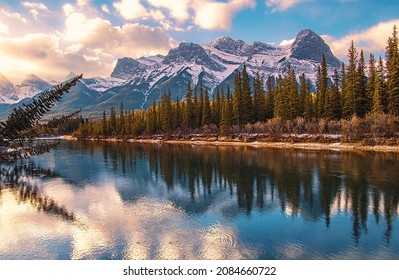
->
xmin=0 ymin=0 xmax=399 ymax=84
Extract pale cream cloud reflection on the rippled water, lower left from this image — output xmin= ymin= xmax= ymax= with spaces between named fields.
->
xmin=0 ymin=179 xmax=258 ymax=259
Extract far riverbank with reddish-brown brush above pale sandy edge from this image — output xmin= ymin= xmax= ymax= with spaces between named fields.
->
xmin=63 ymin=135 xmax=399 ymax=152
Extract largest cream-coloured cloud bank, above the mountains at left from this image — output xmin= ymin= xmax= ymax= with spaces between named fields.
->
xmin=0 ymin=1 xmax=176 ymax=82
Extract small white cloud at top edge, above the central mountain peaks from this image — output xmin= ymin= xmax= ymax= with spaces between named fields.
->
xmin=194 ymin=0 xmax=256 ymax=30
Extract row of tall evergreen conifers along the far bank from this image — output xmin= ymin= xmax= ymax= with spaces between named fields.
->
xmin=76 ymin=26 xmax=399 ymax=137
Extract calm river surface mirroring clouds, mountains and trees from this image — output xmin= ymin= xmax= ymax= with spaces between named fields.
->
xmin=0 ymin=142 xmax=399 ymax=259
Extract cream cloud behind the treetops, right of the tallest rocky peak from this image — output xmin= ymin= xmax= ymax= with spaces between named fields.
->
xmin=322 ymin=19 xmax=399 ymax=61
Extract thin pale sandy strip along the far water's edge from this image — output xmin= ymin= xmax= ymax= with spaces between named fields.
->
xmin=62 ymin=135 xmax=399 ymax=153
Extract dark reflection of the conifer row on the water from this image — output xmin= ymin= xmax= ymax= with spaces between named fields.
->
xmin=94 ymin=143 xmax=399 ymax=243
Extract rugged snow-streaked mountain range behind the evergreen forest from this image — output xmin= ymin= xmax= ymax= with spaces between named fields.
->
xmin=0 ymin=29 xmax=341 ymax=119
